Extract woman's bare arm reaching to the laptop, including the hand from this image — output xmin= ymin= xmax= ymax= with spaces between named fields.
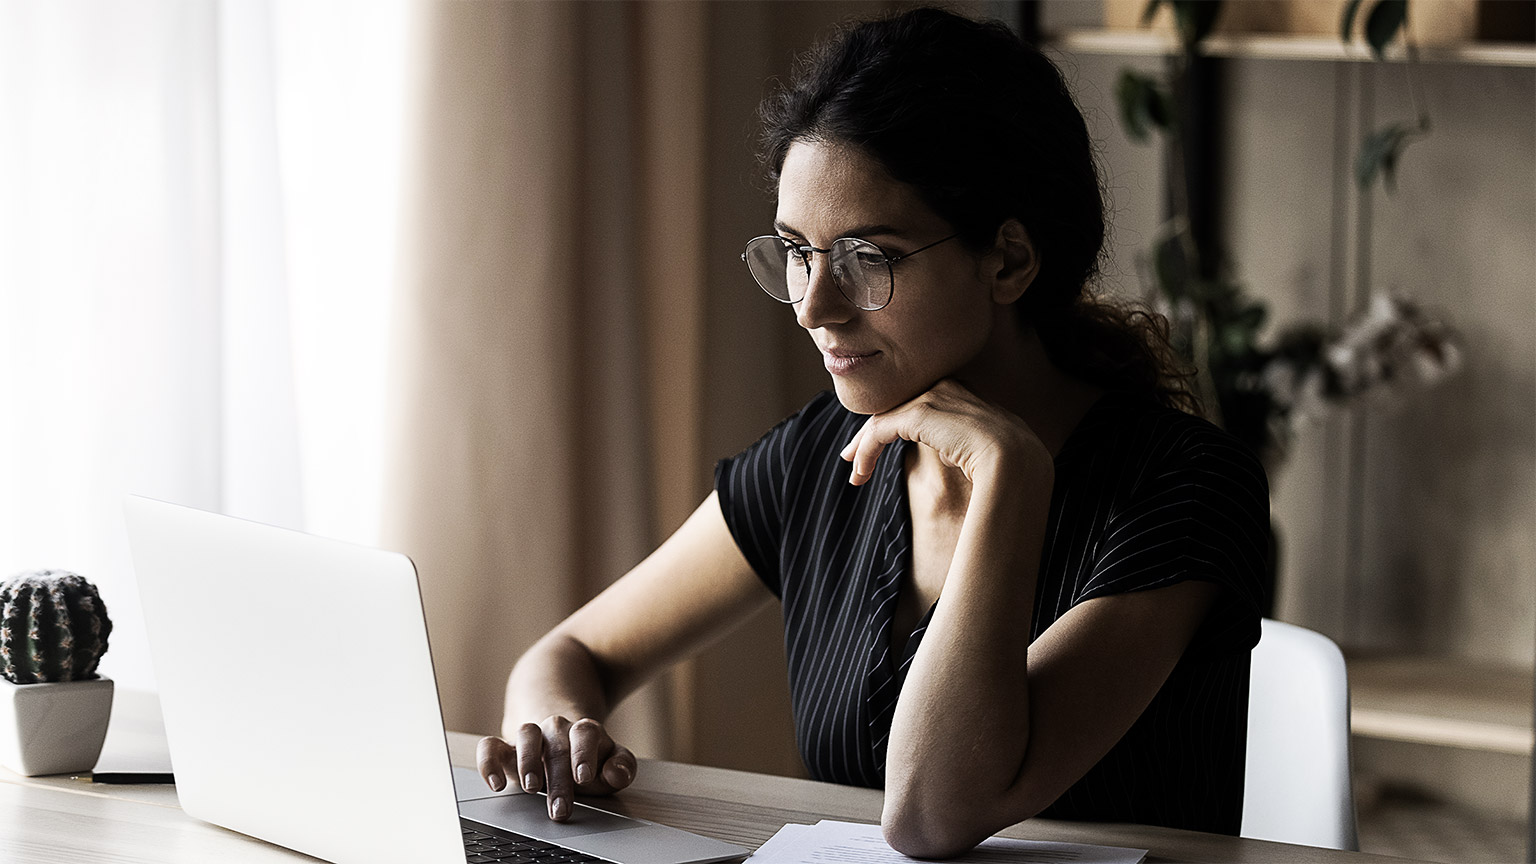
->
xmin=479 ymin=493 xmax=774 ymax=821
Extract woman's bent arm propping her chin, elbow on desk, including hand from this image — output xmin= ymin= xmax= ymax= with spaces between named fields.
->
xmin=845 ymin=383 xmax=1218 ymax=858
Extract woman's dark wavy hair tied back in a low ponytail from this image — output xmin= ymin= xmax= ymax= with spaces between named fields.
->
xmin=759 ymin=8 xmax=1201 ymax=415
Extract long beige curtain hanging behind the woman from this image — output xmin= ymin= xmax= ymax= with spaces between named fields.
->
xmin=384 ymin=2 xmax=921 ymax=773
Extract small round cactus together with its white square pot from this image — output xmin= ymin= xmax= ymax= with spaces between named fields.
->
xmin=0 ymin=570 xmax=112 ymax=776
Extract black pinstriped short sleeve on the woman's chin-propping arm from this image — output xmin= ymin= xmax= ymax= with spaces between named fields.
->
xmin=1074 ymin=423 xmax=1270 ymax=650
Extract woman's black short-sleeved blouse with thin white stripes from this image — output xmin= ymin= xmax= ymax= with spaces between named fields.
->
xmin=714 ymin=392 xmax=1269 ymax=835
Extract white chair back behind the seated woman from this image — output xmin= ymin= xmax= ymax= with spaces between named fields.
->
xmin=1243 ymin=618 xmax=1358 ymax=850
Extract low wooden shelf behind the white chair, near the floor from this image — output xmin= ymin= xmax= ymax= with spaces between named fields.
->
xmin=1347 ymin=656 xmax=1533 ymax=755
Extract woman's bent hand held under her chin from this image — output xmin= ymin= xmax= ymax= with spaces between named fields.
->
xmin=842 ymin=378 xmax=1052 ymax=486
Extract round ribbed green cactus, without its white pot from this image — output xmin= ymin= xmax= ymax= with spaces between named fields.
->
xmin=0 ymin=570 xmax=112 ymax=684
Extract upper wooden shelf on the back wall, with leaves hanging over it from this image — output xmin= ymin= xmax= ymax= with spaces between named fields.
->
xmin=1044 ymin=29 xmax=1536 ymax=68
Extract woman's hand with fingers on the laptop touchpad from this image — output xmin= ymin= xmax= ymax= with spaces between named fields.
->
xmin=476 ymin=715 xmax=636 ymax=822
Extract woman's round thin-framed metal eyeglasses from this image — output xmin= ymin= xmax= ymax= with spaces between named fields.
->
xmin=742 ymin=232 xmax=960 ymax=312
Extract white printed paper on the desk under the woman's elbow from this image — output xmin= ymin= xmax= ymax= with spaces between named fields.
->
xmin=751 ymin=819 xmax=1147 ymax=864
